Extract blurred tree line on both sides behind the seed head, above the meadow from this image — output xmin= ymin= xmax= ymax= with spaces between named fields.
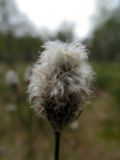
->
xmin=0 ymin=0 xmax=120 ymax=62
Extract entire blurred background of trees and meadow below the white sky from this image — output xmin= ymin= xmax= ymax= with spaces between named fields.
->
xmin=0 ymin=0 xmax=120 ymax=160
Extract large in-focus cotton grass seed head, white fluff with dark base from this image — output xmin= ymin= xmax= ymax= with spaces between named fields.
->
xmin=28 ymin=41 xmax=94 ymax=130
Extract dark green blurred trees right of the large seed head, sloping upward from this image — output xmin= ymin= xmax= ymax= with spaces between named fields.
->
xmin=88 ymin=4 xmax=120 ymax=62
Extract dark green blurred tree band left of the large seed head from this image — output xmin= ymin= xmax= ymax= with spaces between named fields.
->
xmin=0 ymin=34 xmax=43 ymax=63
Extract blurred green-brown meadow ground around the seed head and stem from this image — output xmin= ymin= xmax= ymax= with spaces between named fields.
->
xmin=0 ymin=62 xmax=120 ymax=160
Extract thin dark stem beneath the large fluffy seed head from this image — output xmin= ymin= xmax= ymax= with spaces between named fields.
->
xmin=55 ymin=131 xmax=61 ymax=160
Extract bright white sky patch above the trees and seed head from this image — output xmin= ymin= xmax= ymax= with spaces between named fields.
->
xmin=16 ymin=0 xmax=95 ymax=38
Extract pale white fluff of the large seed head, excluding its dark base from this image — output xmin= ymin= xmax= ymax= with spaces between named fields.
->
xmin=28 ymin=41 xmax=94 ymax=129
